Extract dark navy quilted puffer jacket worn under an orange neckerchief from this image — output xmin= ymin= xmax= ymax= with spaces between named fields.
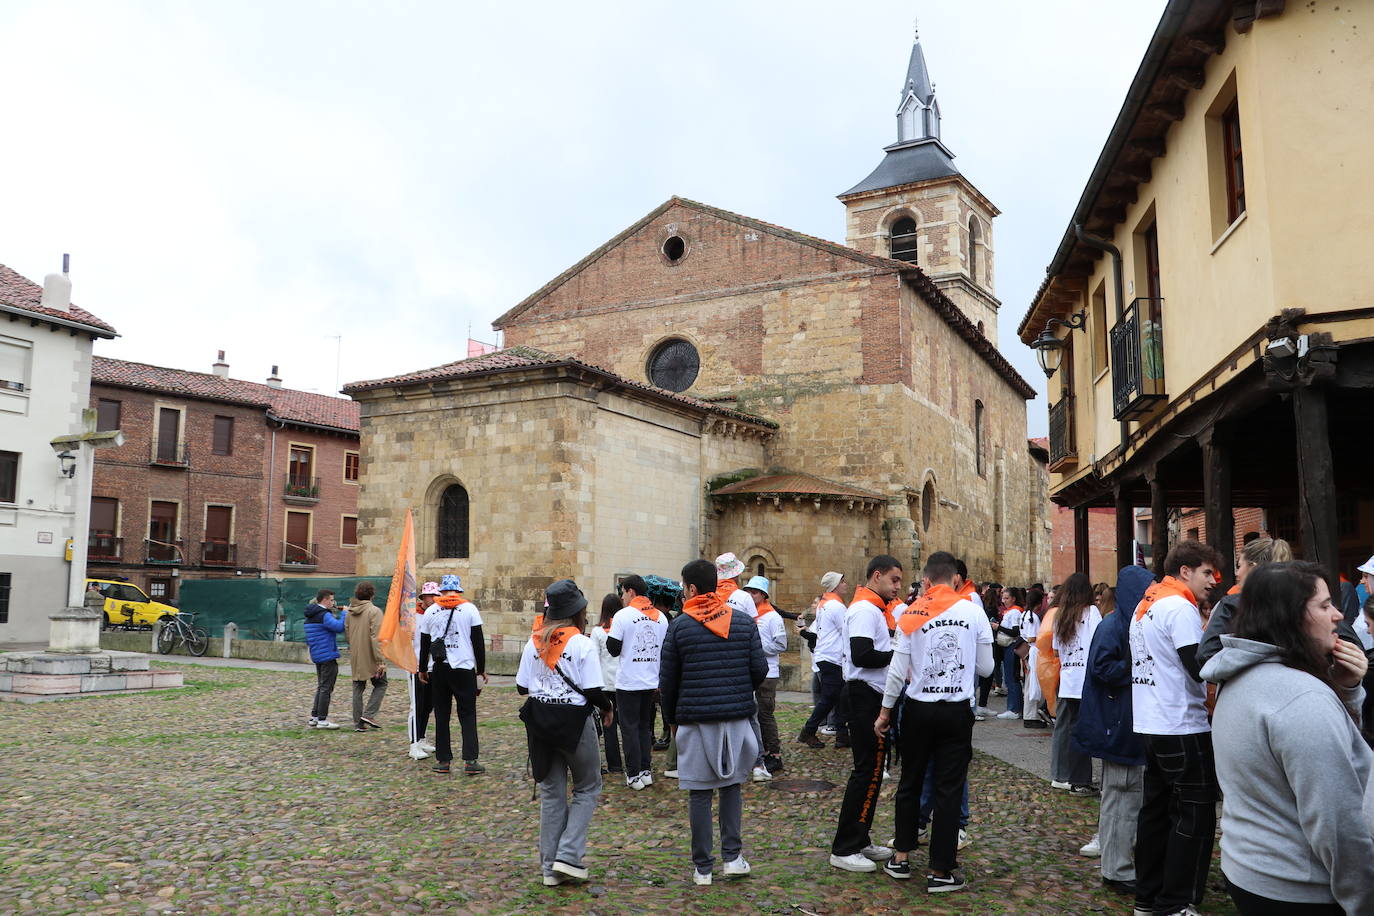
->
xmin=658 ymin=611 xmax=768 ymax=725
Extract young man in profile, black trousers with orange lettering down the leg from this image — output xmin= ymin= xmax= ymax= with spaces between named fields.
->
xmin=830 ymin=553 xmax=903 ymax=872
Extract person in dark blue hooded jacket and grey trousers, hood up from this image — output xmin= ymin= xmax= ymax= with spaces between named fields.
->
xmin=1070 ymin=566 xmax=1154 ymax=895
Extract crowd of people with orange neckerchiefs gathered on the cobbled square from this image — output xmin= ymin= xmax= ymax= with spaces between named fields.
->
xmin=306 ymin=534 xmax=1374 ymax=916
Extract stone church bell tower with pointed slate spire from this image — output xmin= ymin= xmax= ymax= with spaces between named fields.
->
xmin=840 ymin=33 xmax=1002 ymax=343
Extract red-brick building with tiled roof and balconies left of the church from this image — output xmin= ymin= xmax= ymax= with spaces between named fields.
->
xmin=88 ymin=353 xmax=360 ymax=599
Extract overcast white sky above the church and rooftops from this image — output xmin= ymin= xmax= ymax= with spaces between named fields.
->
xmin=0 ymin=0 xmax=1164 ymax=435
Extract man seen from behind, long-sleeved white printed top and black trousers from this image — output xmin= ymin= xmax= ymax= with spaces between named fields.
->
xmin=874 ymin=551 xmax=992 ymax=894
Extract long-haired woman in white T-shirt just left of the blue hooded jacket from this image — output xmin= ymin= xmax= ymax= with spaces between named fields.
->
xmin=1051 ymin=573 xmax=1102 ymax=795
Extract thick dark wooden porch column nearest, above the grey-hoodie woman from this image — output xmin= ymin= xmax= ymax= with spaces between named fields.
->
xmin=1293 ymin=387 xmax=1341 ymax=602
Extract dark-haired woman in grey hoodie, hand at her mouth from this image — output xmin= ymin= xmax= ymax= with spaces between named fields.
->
xmin=1202 ymin=563 xmax=1374 ymax=916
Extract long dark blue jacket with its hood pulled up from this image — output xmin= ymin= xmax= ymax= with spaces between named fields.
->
xmin=1070 ymin=566 xmax=1154 ymax=766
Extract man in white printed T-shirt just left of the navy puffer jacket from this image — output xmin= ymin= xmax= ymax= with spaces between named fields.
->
xmin=606 ymin=575 xmax=668 ymax=790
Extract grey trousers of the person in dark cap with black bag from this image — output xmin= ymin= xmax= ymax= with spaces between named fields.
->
xmin=539 ymin=710 xmax=600 ymax=875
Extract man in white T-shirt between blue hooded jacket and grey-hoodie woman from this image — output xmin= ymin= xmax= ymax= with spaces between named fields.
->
xmin=1118 ymin=541 xmax=1221 ymax=916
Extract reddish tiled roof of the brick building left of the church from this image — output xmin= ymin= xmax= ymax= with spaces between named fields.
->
xmin=91 ymin=356 xmax=359 ymax=433
